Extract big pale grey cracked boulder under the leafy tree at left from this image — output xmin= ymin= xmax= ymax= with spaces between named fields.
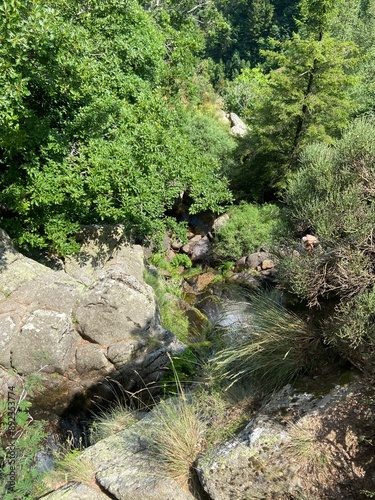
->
xmin=0 ymin=226 xmax=184 ymax=416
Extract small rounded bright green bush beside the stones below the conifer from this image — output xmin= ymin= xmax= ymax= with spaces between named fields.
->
xmin=214 ymin=203 xmax=279 ymax=260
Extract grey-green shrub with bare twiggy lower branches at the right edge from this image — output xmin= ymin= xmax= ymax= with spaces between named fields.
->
xmin=279 ymin=117 xmax=375 ymax=306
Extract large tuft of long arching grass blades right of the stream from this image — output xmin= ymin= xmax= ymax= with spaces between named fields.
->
xmin=211 ymin=292 xmax=320 ymax=392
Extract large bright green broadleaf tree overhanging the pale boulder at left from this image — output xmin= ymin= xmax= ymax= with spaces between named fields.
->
xmin=0 ymin=0 xmax=232 ymax=254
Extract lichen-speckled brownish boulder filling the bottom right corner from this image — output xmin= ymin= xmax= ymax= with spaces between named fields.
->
xmin=198 ymin=381 xmax=374 ymax=500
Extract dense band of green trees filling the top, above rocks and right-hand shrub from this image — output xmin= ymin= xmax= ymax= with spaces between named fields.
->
xmin=0 ymin=0 xmax=375 ymax=254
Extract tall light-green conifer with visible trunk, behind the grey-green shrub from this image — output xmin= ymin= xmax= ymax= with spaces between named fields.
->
xmin=226 ymin=1 xmax=357 ymax=200
